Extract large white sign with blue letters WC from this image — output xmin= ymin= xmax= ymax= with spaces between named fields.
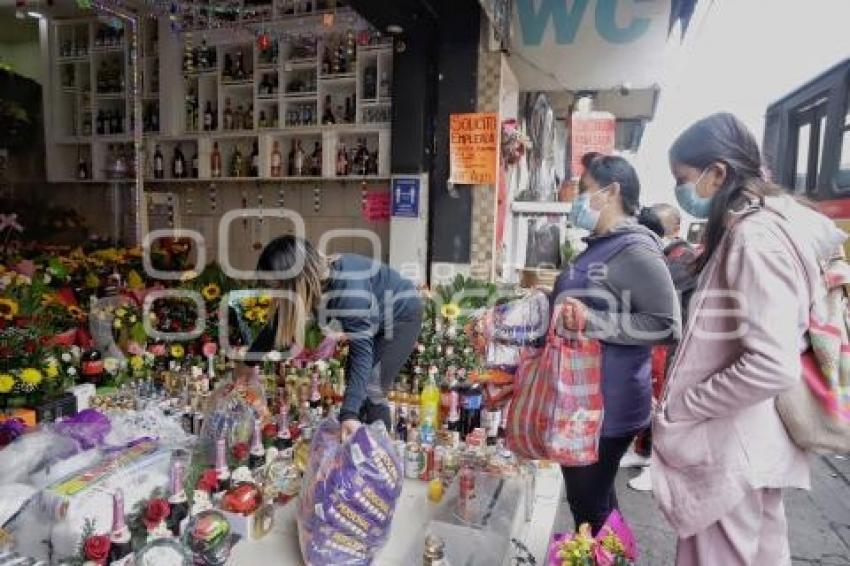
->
xmin=511 ymin=0 xmax=671 ymax=90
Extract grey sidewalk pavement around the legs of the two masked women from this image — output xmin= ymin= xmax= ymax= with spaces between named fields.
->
xmin=541 ymin=456 xmax=850 ymax=566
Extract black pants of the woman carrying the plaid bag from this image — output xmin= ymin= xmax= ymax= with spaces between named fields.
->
xmin=561 ymin=434 xmax=635 ymax=535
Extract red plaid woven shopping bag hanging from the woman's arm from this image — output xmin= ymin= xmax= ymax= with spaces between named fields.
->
xmin=507 ymin=308 xmax=603 ymax=466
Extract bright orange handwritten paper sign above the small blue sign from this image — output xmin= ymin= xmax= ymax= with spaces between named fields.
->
xmin=449 ymin=112 xmax=499 ymax=185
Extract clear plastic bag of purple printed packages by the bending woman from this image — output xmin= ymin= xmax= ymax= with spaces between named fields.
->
xmin=298 ymin=419 xmax=403 ymax=566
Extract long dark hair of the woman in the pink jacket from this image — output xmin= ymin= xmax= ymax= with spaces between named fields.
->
xmin=670 ymin=112 xmax=785 ymax=271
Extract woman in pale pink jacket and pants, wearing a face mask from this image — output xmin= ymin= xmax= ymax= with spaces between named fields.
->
xmin=652 ymin=114 xmax=846 ymax=566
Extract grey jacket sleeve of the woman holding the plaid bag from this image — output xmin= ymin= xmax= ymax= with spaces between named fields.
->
xmin=587 ymin=244 xmax=682 ymax=346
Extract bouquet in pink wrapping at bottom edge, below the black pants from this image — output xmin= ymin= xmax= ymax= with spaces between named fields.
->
xmin=547 ymin=510 xmax=638 ymax=566
